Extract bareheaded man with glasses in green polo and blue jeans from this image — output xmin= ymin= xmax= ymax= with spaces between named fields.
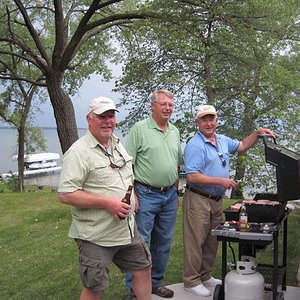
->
xmin=125 ymin=90 xmax=183 ymax=298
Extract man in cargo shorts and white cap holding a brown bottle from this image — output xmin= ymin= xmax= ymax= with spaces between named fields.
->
xmin=58 ymin=97 xmax=151 ymax=300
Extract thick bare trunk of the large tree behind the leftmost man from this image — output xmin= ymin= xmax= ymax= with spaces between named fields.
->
xmin=47 ymin=76 xmax=78 ymax=153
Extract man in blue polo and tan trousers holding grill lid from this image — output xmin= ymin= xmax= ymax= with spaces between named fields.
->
xmin=183 ymin=105 xmax=275 ymax=297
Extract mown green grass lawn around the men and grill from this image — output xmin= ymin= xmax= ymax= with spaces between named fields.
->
xmin=0 ymin=189 xmax=300 ymax=300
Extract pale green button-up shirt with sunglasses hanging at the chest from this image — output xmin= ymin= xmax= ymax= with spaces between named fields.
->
xmin=58 ymin=131 xmax=134 ymax=247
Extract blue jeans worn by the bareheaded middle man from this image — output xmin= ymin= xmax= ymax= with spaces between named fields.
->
xmin=126 ymin=183 xmax=178 ymax=291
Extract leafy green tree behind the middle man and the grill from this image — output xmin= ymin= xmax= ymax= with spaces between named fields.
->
xmin=118 ymin=0 xmax=300 ymax=197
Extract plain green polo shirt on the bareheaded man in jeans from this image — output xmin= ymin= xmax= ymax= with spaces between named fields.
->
xmin=125 ymin=117 xmax=183 ymax=187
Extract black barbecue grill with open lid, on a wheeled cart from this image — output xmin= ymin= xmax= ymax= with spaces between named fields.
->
xmin=211 ymin=135 xmax=300 ymax=300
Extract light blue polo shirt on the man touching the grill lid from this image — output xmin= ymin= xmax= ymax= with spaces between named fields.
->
xmin=184 ymin=131 xmax=239 ymax=196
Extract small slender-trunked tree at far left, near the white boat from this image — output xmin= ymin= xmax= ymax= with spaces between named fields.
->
xmin=0 ymin=45 xmax=46 ymax=191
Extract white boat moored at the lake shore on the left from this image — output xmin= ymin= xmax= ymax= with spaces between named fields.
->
xmin=1 ymin=152 xmax=61 ymax=180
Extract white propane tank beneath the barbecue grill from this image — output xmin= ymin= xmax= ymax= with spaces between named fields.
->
xmin=224 ymin=256 xmax=264 ymax=300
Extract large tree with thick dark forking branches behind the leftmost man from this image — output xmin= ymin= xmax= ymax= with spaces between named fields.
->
xmin=0 ymin=0 xmax=153 ymax=153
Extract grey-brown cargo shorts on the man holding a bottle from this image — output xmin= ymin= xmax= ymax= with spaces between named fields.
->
xmin=75 ymin=234 xmax=151 ymax=292
